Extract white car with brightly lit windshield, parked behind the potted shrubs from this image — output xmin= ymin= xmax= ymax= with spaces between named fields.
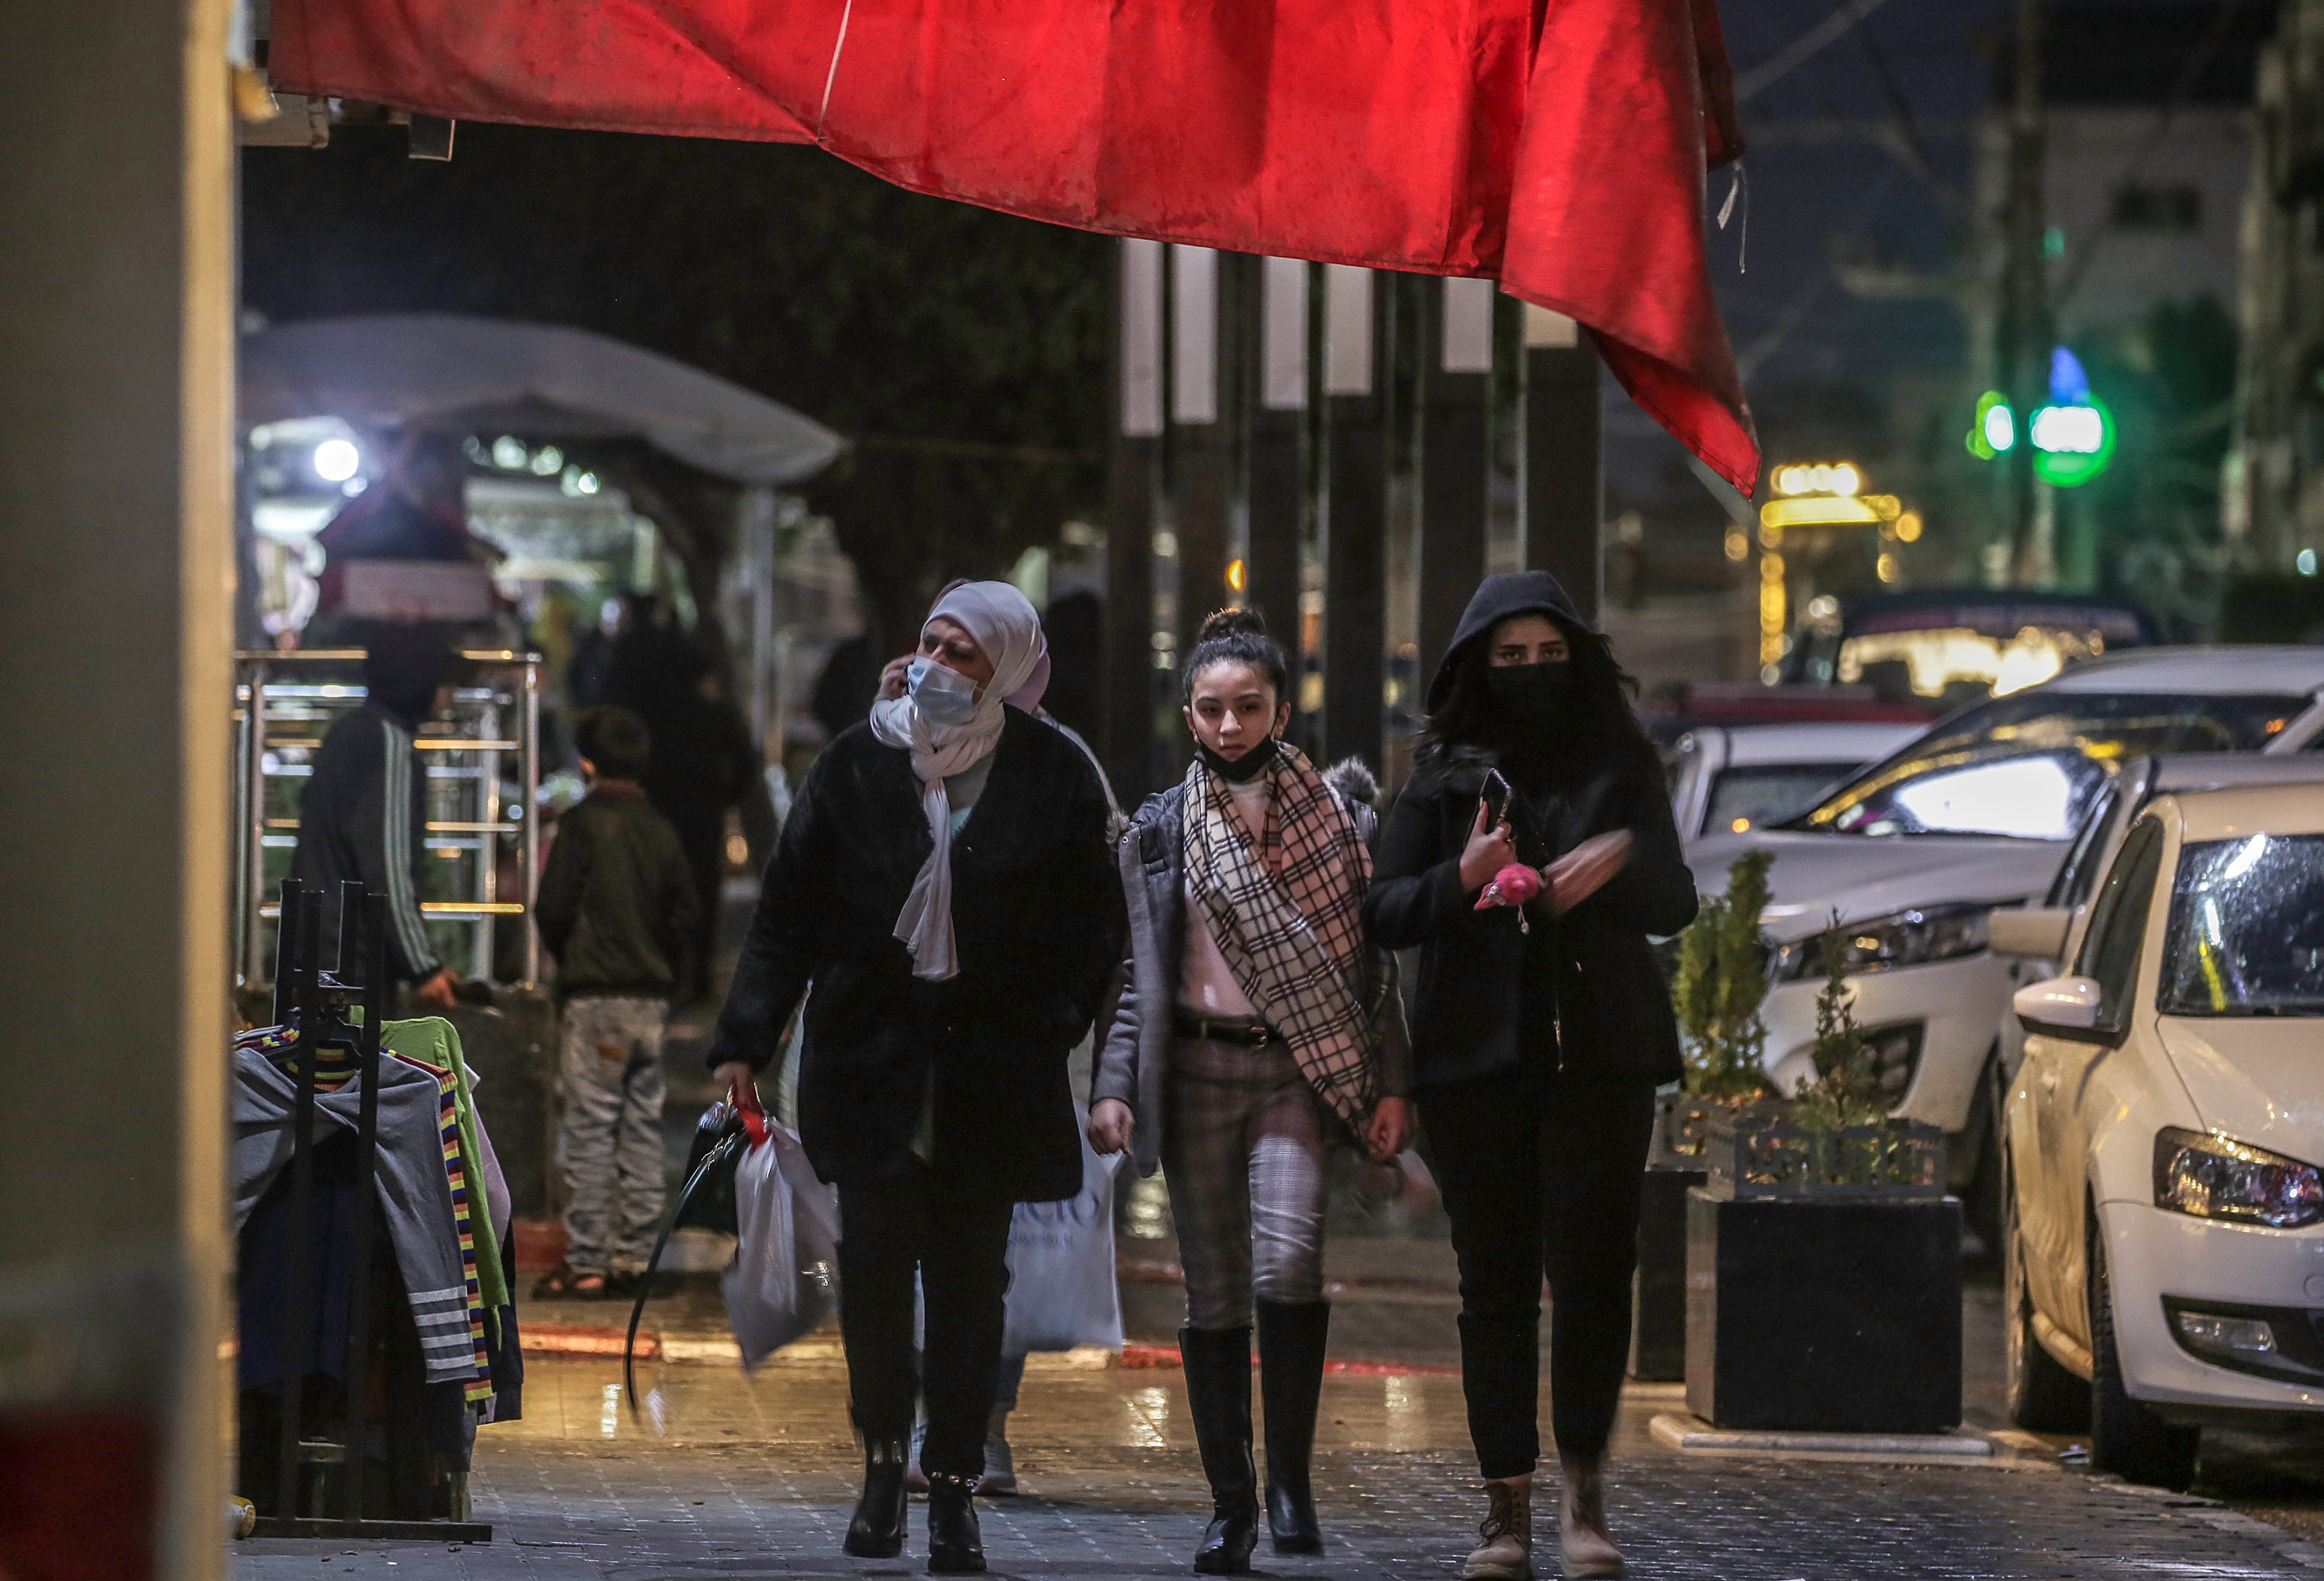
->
xmin=1687 ymin=646 xmax=2324 ymax=1239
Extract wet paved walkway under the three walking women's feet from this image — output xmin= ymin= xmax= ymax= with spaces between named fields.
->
xmin=233 ymin=1358 xmax=2324 ymax=1581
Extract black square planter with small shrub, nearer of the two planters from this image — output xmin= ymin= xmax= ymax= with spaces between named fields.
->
xmin=1685 ymin=918 xmax=1961 ymax=1432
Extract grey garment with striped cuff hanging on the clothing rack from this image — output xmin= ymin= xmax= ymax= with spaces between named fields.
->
xmin=230 ymin=1039 xmax=479 ymax=1384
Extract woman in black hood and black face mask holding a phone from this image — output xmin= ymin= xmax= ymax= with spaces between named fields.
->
xmin=1364 ymin=572 xmax=1696 ymax=1581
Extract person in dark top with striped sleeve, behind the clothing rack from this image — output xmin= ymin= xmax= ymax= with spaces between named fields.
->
xmin=291 ymin=625 xmax=460 ymax=1011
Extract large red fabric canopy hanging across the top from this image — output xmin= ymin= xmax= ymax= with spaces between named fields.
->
xmin=269 ymin=0 xmax=1759 ymax=493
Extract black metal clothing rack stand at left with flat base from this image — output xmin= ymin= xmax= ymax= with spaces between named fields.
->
xmin=253 ymin=879 xmax=493 ymax=1542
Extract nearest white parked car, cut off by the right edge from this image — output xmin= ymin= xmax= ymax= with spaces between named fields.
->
xmin=2001 ymin=763 xmax=2324 ymax=1488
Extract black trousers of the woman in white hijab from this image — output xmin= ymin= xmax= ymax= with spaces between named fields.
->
xmin=839 ymin=1165 xmax=1016 ymax=1481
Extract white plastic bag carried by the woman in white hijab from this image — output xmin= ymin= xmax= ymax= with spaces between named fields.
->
xmin=718 ymin=1097 xmax=839 ymax=1367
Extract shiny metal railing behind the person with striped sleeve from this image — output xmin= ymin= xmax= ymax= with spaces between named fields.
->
xmin=235 ymin=649 xmax=541 ymax=986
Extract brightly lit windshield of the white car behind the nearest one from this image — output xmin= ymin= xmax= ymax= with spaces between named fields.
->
xmin=1785 ymin=690 xmax=2308 ymax=839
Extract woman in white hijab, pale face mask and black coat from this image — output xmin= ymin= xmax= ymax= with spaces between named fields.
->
xmin=709 ymin=581 xmax=1122 ymax=1574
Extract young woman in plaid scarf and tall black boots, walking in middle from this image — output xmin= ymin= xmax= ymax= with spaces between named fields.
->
xmin=1090 ymin=609 xmax=1411 ymax=1574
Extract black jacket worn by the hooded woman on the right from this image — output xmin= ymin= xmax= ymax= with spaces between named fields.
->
xmin=1364 ymin=742 xmax=1696 ymax=1088
